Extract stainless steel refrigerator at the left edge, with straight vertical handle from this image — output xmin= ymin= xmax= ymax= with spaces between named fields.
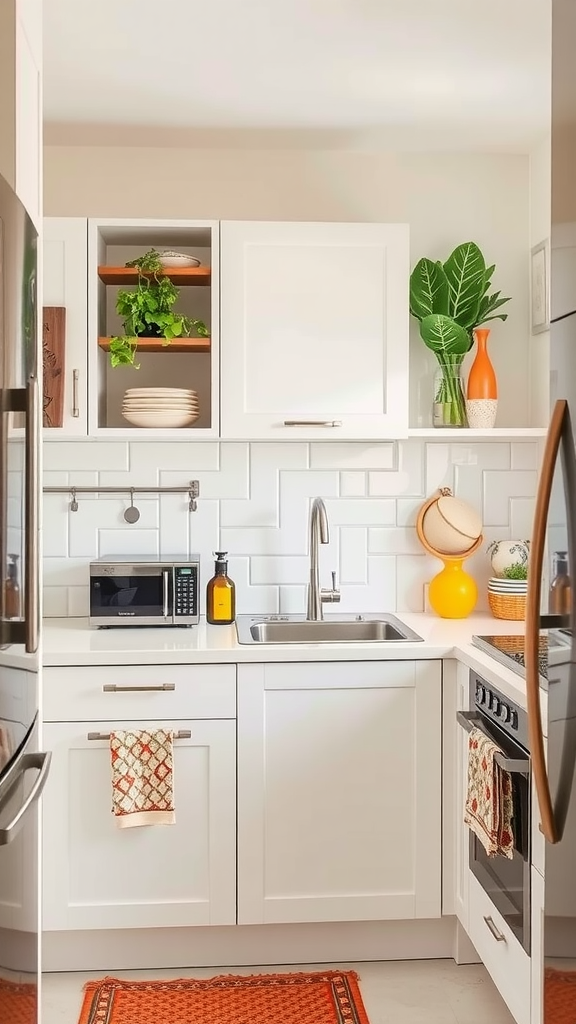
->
xmin=0 ymin=169 xmax=49 ymax=1024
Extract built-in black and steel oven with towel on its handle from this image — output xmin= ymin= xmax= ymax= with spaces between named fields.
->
xmin=458 ymin=672 xmax=531 ymax=953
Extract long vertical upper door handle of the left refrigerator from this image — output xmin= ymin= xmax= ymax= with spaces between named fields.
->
xmin=25 ymin=374 xmax=40 ymax=654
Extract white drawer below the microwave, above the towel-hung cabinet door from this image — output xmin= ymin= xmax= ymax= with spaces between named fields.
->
xmin=43 ymin=665 xmax=236 ymax=722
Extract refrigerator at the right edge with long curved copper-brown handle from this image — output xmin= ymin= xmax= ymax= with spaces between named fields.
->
xmin=526 ymin=0 xmax=576 ymax=1024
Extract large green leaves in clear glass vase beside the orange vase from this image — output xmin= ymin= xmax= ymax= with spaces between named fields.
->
xmin=410 ymin=242 xmax=509 ymax=427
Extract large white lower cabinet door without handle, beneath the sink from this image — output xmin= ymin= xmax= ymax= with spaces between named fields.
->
xmin=238 ymin=662 xmax=442 ymax=925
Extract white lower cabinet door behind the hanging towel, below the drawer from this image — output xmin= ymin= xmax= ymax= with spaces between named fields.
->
xmin=43 ymin=721 xmax=236 ymax=931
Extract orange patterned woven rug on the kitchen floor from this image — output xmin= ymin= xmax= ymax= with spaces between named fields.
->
xmin=78 ymin=971 xmax=369 ymax=1024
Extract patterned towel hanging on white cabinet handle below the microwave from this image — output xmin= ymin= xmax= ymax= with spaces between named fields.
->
xmin=110 ymin=729 xmax=176 ymax=828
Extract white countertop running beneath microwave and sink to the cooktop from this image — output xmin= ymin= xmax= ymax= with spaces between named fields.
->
xmin=42 ymin=612 xmax=525 ymax=696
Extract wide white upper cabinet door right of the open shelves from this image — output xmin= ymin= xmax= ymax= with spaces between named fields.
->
xmin=220 ymin=221 xmax=409 ymax=439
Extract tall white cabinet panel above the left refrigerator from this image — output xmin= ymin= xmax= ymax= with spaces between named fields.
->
xmin=0 ymin=0 xmax=42 ymax=228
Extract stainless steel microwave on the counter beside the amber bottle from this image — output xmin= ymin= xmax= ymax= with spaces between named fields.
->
xmin=89 ymin=555 xmax=200 ymax=627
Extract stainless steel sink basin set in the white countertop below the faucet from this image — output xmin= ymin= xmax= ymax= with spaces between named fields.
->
xmin=236 ymin=614 xmax=422 ymax=644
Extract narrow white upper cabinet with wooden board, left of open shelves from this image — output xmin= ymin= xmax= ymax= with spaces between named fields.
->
xmin=42 ymin=217 xmax=88 ymax=439
